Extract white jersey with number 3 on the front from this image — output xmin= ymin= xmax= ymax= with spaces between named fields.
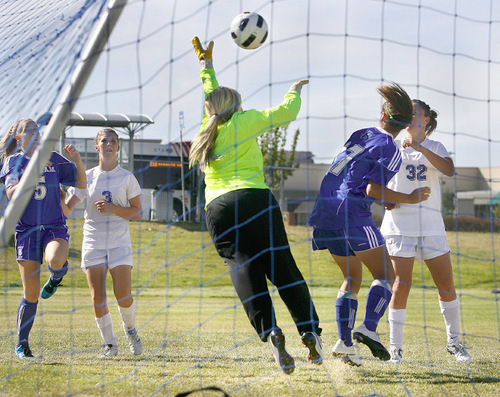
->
xmin=82 ymin=167 xmax=141 ymax=249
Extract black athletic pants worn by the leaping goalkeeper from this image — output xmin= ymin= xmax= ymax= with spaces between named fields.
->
xmin=206 ymin=189 xmax=321 ymax=342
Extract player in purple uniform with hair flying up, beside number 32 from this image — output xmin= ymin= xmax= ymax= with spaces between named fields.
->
xmin=308 ymin=83 xmax=429 ymax=365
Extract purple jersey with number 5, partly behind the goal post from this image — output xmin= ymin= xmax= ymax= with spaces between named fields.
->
xmin=0 ymin=152 xmax=76 ymax=232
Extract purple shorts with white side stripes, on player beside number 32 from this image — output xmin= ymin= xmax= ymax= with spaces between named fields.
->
xmin=312 ymin=224 xmax=385 ymax=256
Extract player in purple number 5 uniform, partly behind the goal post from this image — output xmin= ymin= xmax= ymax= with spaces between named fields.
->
xmin=0 ymin=119 xmax=86 ymax=359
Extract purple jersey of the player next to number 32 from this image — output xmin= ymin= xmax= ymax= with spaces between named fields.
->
xmin=308 ymin=127 xmax=401 ymax=230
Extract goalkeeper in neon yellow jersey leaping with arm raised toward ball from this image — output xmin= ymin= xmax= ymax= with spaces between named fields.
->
xmin=189 ymin=37 xmax=322 ymax=374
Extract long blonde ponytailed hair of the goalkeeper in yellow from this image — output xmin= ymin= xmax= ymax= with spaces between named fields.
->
xmin=189 ymin=87 xmax=241 ymax=170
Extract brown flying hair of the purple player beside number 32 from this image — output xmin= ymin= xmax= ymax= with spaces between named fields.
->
xmin=377 ymin=83 xmax=413 ymax=134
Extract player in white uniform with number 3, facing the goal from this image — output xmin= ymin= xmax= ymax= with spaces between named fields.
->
xmin=65 ymin=128 xmax=142 ymax=358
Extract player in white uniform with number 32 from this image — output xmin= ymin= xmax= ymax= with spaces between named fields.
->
xmin=381 ymin=100 xmax=471 ymax=363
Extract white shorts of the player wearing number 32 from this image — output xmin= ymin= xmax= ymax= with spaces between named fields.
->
xmin=385 ymin=236 xmax=450 ymax=261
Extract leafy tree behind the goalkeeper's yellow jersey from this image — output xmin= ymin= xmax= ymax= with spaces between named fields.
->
xmin=259 ymin=126 xmax=300 ymax=189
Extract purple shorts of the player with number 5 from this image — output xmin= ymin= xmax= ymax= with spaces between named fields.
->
xmin=16 ymin=225 xmax=69 ymax=263
